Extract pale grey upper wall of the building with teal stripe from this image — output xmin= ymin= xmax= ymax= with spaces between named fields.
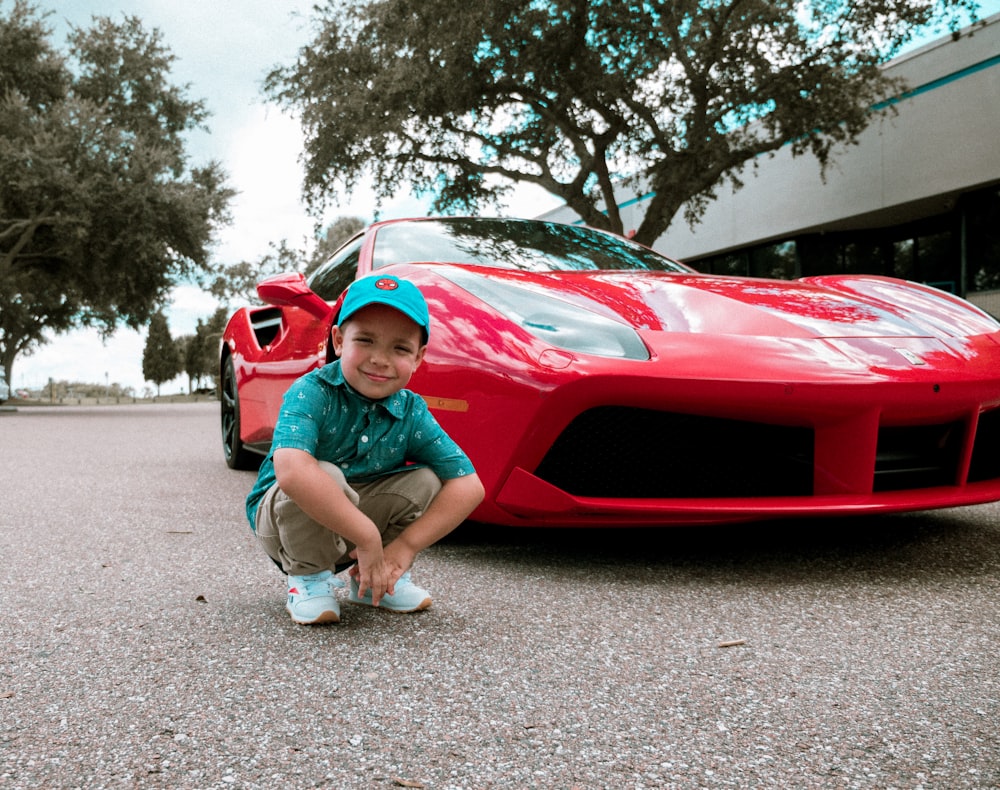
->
xmin=544 ymin=15 xmax=1000 ymax=259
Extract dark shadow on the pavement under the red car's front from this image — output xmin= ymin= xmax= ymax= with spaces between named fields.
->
xmin=438 ymin=506 xmax=1000 ymax=578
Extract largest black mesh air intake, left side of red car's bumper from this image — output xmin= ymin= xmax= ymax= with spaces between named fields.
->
xmin=535 ymin=406 xmax=813 ymax=499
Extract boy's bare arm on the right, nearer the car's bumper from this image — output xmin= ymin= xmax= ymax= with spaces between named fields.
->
xmin=385 ymin=474 xmax=486 ymax=582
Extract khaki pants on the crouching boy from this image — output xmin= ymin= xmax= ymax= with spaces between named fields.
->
xmin=257 ymin=461 xmax=441 ymax=576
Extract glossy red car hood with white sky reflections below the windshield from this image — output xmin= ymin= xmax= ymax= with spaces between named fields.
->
xmin=450 ymin=267 xmax=1000 ymax=339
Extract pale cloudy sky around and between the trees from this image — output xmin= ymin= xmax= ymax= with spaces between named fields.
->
xmin=10 ymin=0 xmax=1000 ymax=395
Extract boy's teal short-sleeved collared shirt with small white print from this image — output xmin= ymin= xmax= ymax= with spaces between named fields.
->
xmin=246 ymin=360 xmax=475 ymax=530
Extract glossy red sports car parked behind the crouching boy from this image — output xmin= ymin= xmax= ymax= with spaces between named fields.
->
xmin=220 ymin=218 xmax=1000 ymax=526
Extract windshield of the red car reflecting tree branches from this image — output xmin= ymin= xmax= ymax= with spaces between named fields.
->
xmin=373 ymin=218 xmax=686 ymax=272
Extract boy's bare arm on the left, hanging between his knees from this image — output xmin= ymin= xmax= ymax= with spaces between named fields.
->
xmin=274 ymin=448 xmax=390 ymax=605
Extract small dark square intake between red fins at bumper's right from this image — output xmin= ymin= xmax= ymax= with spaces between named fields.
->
xmin=874 ymin=422 xmax=963 ymax=491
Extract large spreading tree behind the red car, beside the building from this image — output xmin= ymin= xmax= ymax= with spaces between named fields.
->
xmin=265 ymin=0 xmax=976 ymax=244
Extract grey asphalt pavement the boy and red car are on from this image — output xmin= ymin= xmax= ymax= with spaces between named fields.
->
xmin=0 ymin=403 xmax=1000 ymax=790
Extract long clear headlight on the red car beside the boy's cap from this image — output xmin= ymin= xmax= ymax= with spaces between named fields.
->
xmin=440 ymin=269 xmax=649 ymax=360
